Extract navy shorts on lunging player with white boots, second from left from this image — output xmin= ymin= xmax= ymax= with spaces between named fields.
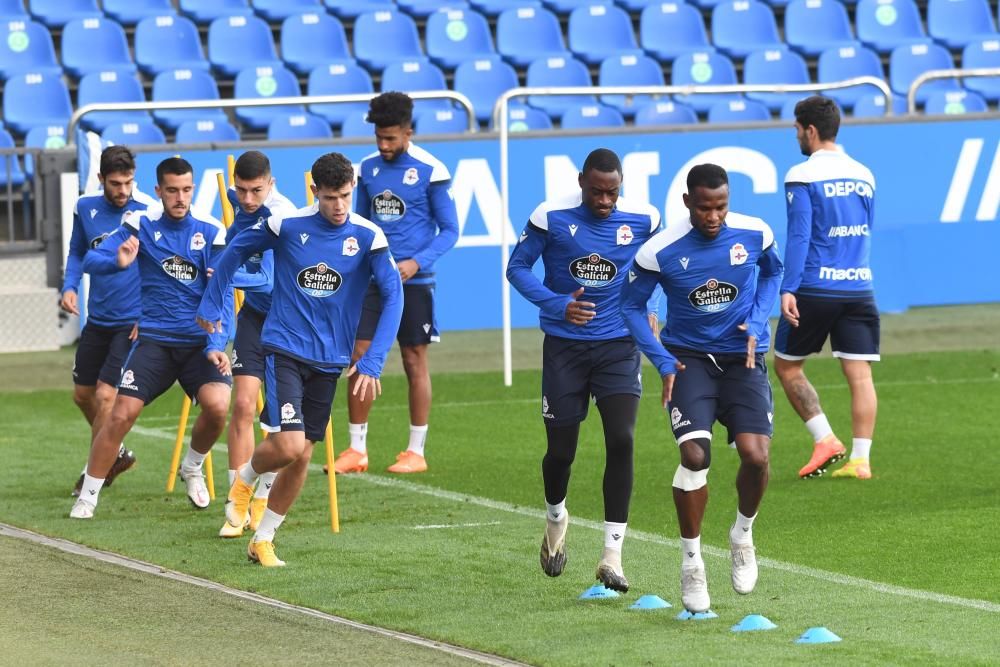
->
xmin=118 ymin=339 xmax=233 ymax=405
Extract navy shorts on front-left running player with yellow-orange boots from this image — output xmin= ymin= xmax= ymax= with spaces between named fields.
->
xmin=260 ymin=353 xmax=340 ymax=442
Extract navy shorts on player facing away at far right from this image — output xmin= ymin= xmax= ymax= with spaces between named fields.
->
xmin=774 ymin=295 xmax=881 ymax=361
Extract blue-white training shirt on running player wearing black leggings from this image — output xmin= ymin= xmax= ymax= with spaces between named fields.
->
xmin=507 ymin=192 xmax=660 ymax=340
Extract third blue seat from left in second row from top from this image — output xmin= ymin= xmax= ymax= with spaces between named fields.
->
xmin=135 ymin=14 xmax=210 ymax=76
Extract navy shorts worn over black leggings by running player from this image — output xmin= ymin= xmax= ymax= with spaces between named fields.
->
xmin=542 ymin=334 xmax=642 ymax=426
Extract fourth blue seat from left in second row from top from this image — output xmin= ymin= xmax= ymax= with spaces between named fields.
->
xmin=208 ymin=16 xmax=282 ymax=77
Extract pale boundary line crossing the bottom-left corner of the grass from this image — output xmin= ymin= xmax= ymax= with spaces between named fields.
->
xmin=0 ymin=523 xmax=523 ymax=665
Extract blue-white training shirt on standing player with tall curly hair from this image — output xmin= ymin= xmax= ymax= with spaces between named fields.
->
xmin=355 ymin=143 xmax=458 ymax=285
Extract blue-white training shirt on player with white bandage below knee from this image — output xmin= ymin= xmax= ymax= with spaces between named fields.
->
xmin=622 ymin=211 xmax=782 ymax=376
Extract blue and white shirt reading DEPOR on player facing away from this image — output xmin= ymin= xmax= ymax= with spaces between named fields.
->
xmin=781 ymin=150 xmax=875 ymax=299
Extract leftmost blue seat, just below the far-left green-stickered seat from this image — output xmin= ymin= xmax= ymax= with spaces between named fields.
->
xmin=3 ymin=72 xmax=73 ymax=135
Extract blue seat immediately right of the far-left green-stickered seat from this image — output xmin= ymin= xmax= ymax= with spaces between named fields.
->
xmin=62 ymin=18 xmax=136 ymax=79
